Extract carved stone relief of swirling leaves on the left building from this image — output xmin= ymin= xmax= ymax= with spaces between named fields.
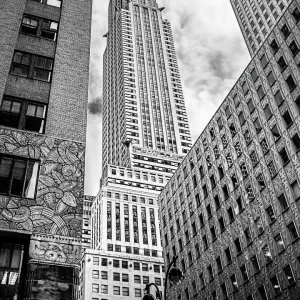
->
xmin=0 ymin=129 xmax=85 ymax=239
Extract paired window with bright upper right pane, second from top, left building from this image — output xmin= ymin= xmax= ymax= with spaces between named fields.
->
xmin=20 ymin=15 xmax=58 ymax=41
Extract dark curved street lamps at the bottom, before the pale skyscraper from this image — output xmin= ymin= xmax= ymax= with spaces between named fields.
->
xmin=143 ymin=255 xmax=184 ymax=300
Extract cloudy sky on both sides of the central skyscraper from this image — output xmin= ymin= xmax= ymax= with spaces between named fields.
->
xmin=85 ymin=0 xmax=250 ymax=195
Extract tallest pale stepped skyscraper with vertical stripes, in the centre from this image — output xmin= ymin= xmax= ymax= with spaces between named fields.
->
xmin=80 ymin=0 xmax=191 ymax=300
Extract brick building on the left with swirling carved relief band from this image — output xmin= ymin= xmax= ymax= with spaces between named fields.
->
xmin=0 ymin=0 xmax=92 ymax=300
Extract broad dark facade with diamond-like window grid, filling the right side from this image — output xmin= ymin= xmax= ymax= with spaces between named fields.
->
xmin=158 ymin=1 xmax=300 ymax=300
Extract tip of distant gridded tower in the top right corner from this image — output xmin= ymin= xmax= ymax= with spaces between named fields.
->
xmin=230 ymin=0 xmax=291 ymax=57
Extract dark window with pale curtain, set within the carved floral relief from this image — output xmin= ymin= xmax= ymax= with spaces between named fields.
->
xmin=0 ymin=154 xmax=40 ymax=199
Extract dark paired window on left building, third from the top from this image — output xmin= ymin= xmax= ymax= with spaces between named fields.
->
xmin=10 ymin=51 xmax=53 ymax=82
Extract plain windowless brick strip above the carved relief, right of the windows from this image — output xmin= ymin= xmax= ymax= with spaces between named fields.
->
xmin=46 ymin=0 xmax=92 ymax=141
